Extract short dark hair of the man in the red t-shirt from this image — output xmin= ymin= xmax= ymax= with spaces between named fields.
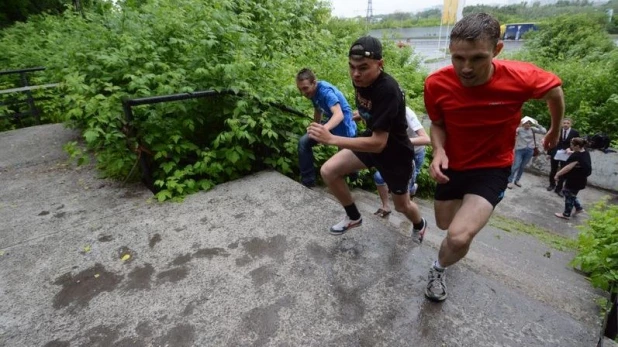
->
xmin=450 ymin=13 xmax=500 ymax=46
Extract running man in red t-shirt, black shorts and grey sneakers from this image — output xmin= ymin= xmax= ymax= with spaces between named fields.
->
xmin=424 ymin=13 xmax=564 ymax=301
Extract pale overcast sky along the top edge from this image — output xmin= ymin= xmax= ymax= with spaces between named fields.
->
xmin=330 ymin=0 xmax=512 ymax=17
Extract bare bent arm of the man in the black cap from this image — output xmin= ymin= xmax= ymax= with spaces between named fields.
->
xmin=307 ymin=123 xmax=388 ymax=153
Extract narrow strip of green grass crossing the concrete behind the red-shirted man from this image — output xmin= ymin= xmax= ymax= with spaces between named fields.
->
xmin=489 ymin=215 xmax=577 ymax=251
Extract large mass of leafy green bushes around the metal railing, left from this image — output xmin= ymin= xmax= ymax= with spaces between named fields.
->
xmin=0 ymin=0 xmax=423 ymax=200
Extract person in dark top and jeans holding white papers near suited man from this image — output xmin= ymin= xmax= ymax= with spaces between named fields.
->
xmin=554 ymin=137 xmax=592 ymax=219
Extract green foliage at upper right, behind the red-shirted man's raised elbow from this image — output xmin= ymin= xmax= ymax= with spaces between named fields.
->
xmin=515 ymin=14 xmax=618 ymax=140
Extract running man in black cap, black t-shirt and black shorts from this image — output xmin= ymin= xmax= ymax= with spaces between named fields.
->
xmin=307 ymin=36 xmax=427 ymax=243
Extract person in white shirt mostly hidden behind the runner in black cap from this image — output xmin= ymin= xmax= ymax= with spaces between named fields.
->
xmin=373 ymin=107 xmax=431 ymax=218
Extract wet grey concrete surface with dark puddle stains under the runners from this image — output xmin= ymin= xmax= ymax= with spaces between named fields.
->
xmin=0 ymin=125 xmax=612 ymax=347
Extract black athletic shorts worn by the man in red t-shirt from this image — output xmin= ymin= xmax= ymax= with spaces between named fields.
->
xmin=435 ymin=166 xmax=511 ymax=207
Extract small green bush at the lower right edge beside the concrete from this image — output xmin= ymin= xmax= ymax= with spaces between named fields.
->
xmin=572 ymin=201 xmax=618 ymax=293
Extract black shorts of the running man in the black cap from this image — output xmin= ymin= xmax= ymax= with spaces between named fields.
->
xmin=352 ymin=151 xmax=414 ymax=195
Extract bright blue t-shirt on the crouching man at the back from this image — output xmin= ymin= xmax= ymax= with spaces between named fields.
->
xmin=311 ymin=81 xmax=356 ymax=137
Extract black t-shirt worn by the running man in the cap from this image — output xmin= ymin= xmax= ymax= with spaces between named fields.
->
xmin=355 ymin=72 xmax=414 ymax=165
